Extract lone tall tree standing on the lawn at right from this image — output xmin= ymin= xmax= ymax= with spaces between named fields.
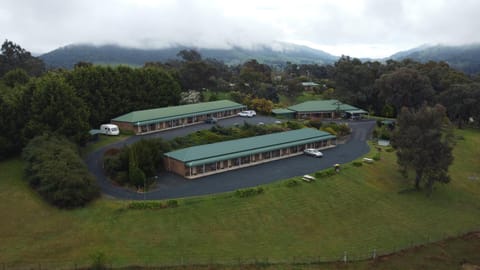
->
xmin=391 ymin=105 xmax=453 ymax=194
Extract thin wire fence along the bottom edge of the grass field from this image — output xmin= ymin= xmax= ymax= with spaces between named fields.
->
xmin=0 ymin=228 xmax=480 ymax=270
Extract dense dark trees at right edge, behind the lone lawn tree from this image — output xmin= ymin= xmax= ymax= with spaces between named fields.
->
xmin=332 ymin=57 xmax=480 ymax=119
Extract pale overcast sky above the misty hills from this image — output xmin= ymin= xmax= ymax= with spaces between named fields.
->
xmin=0 ymin=0 xmax=480 ymax=57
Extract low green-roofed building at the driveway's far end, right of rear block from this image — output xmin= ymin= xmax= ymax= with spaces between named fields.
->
xmin=272 ymin=99 xmax=368 ymax=119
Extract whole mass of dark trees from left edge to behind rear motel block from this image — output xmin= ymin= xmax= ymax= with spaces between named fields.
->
xmin=0 ymin=40 xmax=181 ymax=159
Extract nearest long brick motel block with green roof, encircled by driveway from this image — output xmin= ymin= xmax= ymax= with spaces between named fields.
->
xmin=164 ymin=128 xmax=336 ymax=179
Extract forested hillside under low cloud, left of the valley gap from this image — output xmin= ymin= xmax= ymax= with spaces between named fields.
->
xmin=40 ymin=43 xmax=338 ymax=68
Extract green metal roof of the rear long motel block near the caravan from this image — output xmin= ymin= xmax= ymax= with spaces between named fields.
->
xmin=112 ymin=100 xmax=245 ymax=124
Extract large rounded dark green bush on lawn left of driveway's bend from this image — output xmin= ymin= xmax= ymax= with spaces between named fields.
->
xmin=23 ymin=134 xmax=100 ymax=208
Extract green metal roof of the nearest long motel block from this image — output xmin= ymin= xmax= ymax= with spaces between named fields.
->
xmin=165 ymin=128 xmax=335 ymax=167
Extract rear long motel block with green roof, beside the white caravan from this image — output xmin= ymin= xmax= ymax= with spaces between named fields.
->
xmin=111 ymin=100 xmax=246 ymax=135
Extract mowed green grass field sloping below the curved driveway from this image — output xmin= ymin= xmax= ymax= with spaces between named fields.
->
xmin=0 ymin=130 xmax=480 ymax=268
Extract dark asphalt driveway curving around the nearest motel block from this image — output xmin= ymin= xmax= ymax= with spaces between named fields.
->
xmin=86 ymin=116 xmax=375 ymax=200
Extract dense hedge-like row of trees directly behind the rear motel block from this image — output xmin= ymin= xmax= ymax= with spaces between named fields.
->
xmin=63 ymin=64 xmax=181 ymax=127
